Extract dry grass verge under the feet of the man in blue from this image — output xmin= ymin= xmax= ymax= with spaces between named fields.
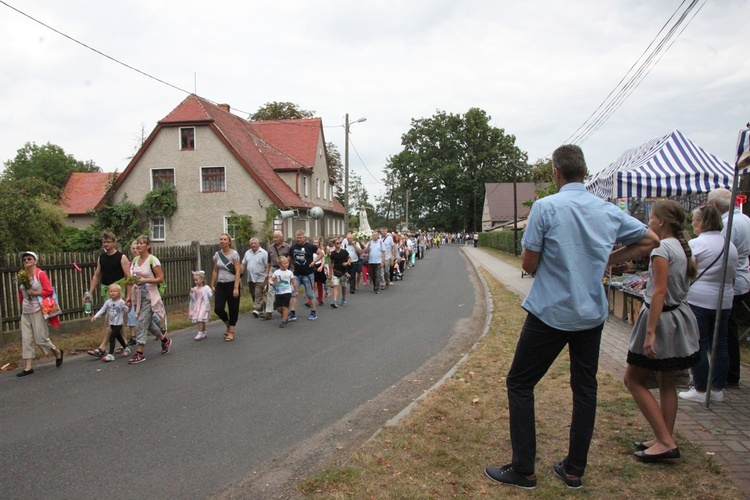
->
xmin=299 ymin=272 xmax=742 ymax=499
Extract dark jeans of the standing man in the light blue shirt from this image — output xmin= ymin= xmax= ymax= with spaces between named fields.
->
xmin=506 ymin=314 xmax=604 ymax=476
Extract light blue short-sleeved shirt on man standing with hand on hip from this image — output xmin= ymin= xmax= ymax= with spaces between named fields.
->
xmin=521 ymin=182 xmax=648 ymax=331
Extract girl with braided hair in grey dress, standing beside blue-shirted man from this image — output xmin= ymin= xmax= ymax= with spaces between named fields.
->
xmin=625 ymin=200 xmax=699 ymax=462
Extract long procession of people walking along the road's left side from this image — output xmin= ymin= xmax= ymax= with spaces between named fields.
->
xmin=11 ymin=228 xmax=445 ymax=377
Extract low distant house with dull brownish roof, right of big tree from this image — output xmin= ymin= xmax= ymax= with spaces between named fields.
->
xmin=482 ymin=182 xmax=546 ymax=231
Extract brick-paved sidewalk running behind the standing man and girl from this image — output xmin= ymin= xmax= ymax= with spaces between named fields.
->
xmin=463 ymin=246 xmax=750 ymax=498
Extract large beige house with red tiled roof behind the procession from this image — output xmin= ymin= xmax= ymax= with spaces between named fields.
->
xmin=113 ymin=94 xmax=344 ymax=245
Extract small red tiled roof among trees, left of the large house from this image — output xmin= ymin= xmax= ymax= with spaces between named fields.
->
xmin=60 ymin=172 xmax=113 ymax=229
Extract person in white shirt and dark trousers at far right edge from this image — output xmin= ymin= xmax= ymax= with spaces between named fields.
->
xmin=706 ymin=188 xmax=750 ymax=386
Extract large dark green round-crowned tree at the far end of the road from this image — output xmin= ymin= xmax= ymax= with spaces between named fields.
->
xmin=388 ymin=108 xmax=527 ymax=231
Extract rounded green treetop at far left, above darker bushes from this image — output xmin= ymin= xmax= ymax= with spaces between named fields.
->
xmin=3 ymin=142 xmax=102 ymax=196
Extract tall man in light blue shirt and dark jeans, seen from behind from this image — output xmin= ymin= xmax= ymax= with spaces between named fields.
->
xmin=485 ymin=145 xmax=659 ymax=489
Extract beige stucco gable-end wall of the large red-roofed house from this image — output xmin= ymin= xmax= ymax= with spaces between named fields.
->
xmin=115 ymin=126 xmax=275 ymax=246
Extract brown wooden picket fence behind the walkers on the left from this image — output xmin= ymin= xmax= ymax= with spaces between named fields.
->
xmin=0 ymin=242 xmax=253 ymax=345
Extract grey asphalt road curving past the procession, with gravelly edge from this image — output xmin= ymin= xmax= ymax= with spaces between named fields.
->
xmin=0 ymin=246 xmax=483 ymax=499
